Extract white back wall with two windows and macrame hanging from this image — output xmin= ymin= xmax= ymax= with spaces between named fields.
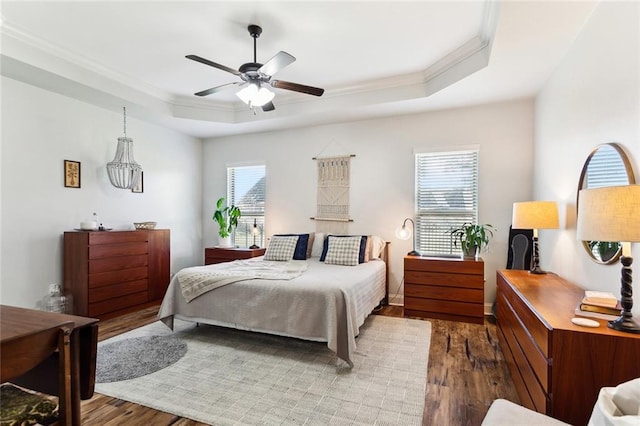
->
xmin=202 ymin=100 xmax=533 ymax=304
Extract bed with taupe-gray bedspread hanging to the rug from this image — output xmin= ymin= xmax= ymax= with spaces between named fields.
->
xmin=158 ymin=235 xmax=388 ymax=367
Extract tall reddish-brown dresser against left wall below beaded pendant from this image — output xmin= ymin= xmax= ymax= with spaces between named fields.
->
xmin=64 ymin=229 xmax=171 ymax=319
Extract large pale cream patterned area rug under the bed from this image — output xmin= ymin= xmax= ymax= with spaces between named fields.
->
xmin=96 ymin=315 xmax=431 ymax=425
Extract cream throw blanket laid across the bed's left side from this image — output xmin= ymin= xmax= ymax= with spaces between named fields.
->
xmin=177 ymin=260 xmax=307 ymax=303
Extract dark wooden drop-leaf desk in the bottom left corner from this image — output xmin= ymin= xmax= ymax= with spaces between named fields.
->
xmin=0 ymin=305 xmax=98 ymax=425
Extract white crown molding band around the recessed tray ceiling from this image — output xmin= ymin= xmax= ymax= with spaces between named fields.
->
xmin=0 ymin=1 xmax=499 ymax=131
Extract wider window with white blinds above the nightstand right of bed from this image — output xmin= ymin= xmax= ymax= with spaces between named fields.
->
xmin=415 ymin=149 xmax=478 ymax=255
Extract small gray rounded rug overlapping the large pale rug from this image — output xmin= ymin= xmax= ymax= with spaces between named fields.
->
xmin=96 ymin=336 xmax=187 ymax=383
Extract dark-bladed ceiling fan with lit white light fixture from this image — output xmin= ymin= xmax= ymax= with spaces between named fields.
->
xmin=186 ymin=25 xmax=324 ymax=111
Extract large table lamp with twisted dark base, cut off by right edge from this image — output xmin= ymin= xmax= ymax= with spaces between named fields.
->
xmin=576 ymin=185 xmax=640 ymax=333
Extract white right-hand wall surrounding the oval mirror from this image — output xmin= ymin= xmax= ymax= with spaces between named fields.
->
xmin=534 ymin=2 xmax=640 ymax=314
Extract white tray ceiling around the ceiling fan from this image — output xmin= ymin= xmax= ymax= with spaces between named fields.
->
xmin=0 ymin=0 xmax=596 ymax=137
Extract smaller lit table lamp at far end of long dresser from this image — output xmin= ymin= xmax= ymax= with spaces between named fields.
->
xmin=511 ymin=201 xmax=560 ymax=274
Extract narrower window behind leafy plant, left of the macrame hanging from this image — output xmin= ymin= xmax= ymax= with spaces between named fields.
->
xmin=227 ymin=165 xmax=265 ymax=247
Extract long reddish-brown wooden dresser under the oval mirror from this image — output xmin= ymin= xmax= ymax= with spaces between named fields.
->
xmin=496 ymin=270 xmax=640 ymax=425
